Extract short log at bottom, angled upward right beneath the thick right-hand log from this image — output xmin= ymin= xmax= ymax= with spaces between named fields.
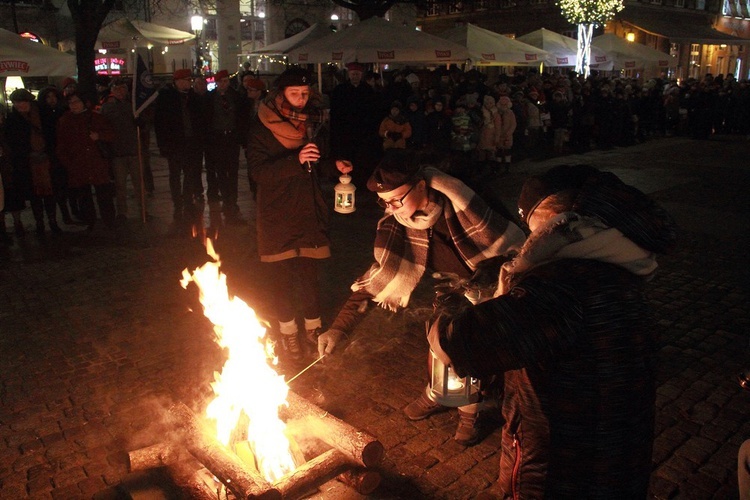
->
xmin=274 ymin=450 xmax=352 ymax=498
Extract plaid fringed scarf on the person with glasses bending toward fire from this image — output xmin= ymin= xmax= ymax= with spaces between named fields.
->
xmin=352 ymin=167 xmax=524 ymax=311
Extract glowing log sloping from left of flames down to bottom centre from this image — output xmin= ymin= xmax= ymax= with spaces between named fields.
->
xmin=169 ymin=403 xmax=281 ymax=499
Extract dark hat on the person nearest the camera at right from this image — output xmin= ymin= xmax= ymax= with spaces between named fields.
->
xmin=518 ymin=165 xmax=599 ymax=223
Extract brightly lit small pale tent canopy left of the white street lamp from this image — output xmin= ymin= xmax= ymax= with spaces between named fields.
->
xmin=60 ymin=17 xmax=195 ymax=51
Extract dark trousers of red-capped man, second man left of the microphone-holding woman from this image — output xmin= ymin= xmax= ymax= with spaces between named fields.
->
xmin=167 ymin=139 xmax=203 ymax=212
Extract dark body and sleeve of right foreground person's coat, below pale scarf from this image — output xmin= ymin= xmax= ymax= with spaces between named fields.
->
xmin=443 ymin=259 xmax=656 ymax=499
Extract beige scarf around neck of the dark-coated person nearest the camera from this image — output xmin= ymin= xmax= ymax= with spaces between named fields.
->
xmin=495 ymin=212 xmax=657 ymax=297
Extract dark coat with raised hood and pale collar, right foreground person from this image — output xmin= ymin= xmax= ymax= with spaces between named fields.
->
xmin=439 ymin=170 xmax=675 ymax=499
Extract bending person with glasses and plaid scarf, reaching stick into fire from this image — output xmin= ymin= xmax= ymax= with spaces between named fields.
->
xmin=310 ymin=149 xmax=525 ymax=446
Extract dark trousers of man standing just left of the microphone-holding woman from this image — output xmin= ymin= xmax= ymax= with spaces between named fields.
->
xmin=206 ymin=132 xmax=240 ymax=213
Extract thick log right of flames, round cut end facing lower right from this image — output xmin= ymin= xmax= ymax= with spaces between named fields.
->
xmin=281 ymin=391 xmax=385 ymax=467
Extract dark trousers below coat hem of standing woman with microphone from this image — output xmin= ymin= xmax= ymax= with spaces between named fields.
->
xmin=266 ymin=257 xmax=320 ymax=321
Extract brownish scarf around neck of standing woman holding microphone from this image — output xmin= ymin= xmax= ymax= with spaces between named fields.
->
xmin=258 ymin=91 xmax=325 ymax=149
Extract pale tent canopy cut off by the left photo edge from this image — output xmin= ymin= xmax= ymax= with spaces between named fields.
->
xmin=0 ymin=28 xmax=77 ymax=77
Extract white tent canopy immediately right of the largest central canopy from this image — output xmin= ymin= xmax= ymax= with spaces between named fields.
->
xmin=438 ymin=23 xmax=549 ymax=66
